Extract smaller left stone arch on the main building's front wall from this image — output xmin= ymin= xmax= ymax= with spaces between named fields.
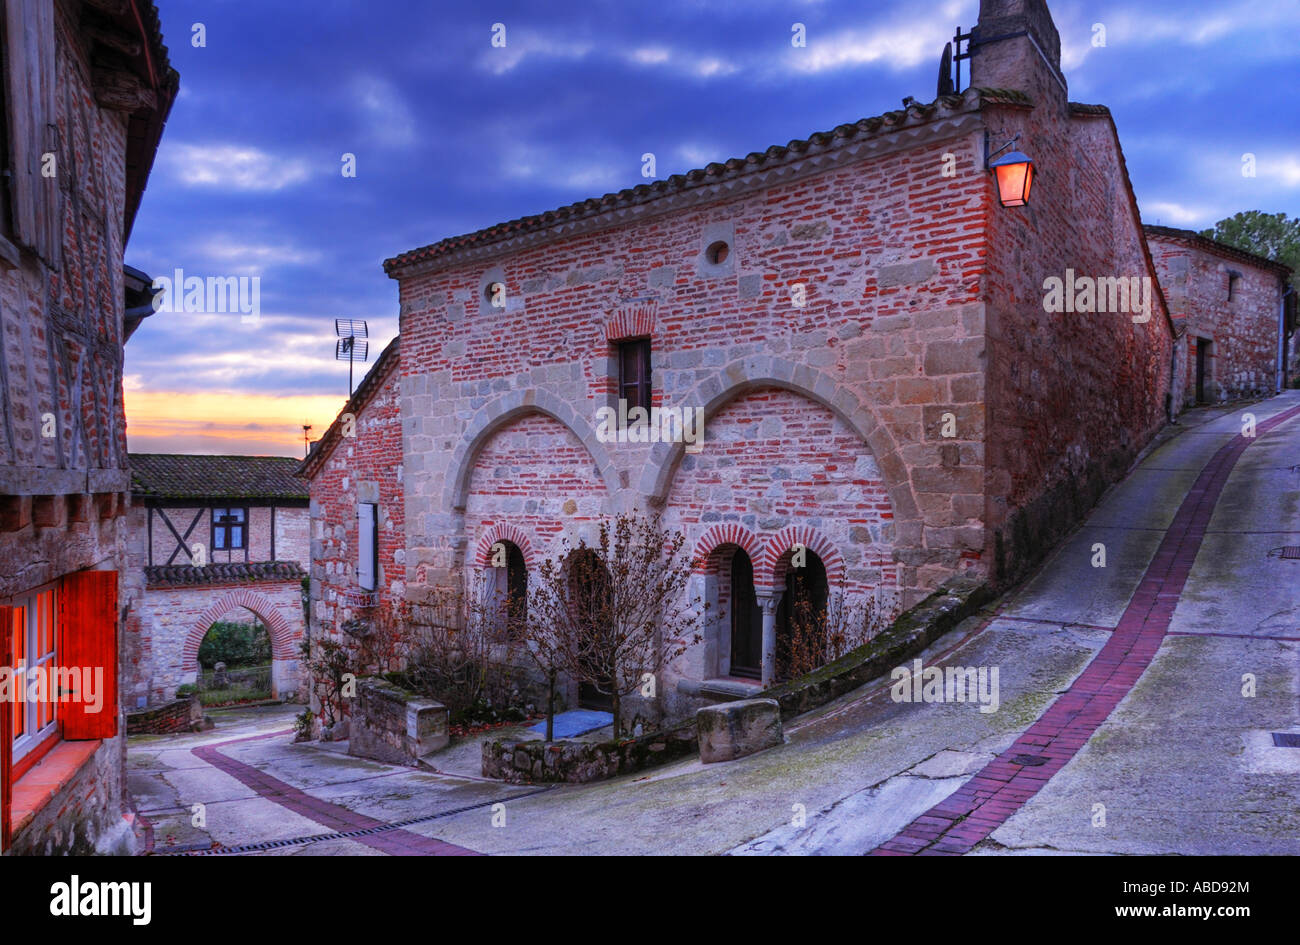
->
xmin=443 ymin=387 xmax=620 ymax=512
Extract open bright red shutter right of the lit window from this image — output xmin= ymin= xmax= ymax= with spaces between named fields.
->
xmin=59 ymin=571 xmax=117 ymax=740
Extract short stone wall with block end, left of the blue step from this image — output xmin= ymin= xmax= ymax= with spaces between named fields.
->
xmin=347 ymin=679 xmax=451 ymax=764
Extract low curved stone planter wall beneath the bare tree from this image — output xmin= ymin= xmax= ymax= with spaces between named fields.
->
xmin=482 ymin=720 xmax=699 ymax=784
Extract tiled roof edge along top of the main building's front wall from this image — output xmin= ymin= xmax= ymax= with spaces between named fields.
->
xmin=384 ymin=87 xmax=1032 ymax=276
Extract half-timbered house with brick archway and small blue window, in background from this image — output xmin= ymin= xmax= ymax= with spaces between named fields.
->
xmin=122 ymin=452 xmax=308 ymax=707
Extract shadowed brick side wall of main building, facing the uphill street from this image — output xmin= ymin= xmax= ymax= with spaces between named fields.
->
xmin=977 ymin=0 xmax=1174 ymax=585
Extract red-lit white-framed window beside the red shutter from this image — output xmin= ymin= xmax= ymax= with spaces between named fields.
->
xmin=9 ymin=586 xmax=60 ymax=762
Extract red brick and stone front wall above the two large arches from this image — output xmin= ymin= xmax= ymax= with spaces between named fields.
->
xmin=400 ymin=124 xmax=984 ymax=597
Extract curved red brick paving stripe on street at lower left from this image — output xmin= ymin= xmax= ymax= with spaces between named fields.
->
xmin=190 ymin=728 xmax=482 ymax=857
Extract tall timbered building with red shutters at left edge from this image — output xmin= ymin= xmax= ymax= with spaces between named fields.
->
xmin=0 ymin=0 xmax=178 ymax=854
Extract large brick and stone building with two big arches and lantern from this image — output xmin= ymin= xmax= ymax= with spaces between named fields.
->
xmin=374 ymin=0 xmax=1175 ymax=711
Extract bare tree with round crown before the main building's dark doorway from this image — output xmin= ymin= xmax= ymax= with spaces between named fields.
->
xmin=528 ymin=513 xmax=707 ymax=737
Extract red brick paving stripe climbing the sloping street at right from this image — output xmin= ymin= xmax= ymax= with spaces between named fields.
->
xmin=870 ymin=407 xmax=1300 ymax=857
